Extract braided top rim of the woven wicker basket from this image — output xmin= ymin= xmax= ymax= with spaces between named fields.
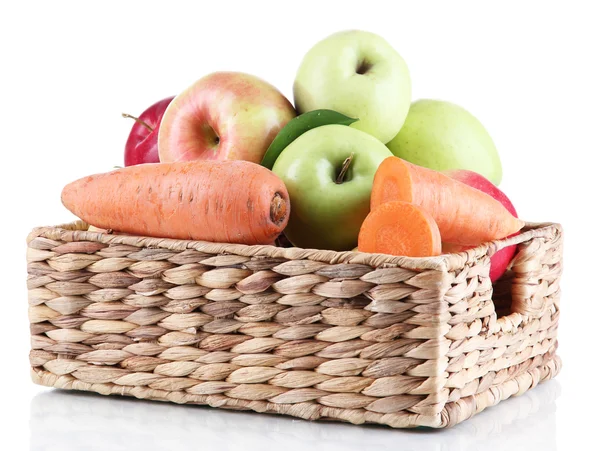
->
xmin=27 ymin=220 xmax=562 ymax=271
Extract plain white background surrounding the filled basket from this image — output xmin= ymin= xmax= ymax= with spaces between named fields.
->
xmin=0 ymin=0 xmax=600 ymax=451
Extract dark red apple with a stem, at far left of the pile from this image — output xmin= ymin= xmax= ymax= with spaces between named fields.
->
xmin=123 ymin=97 xmax=175 ymax=166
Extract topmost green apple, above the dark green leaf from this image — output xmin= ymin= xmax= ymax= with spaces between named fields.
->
xmin=294 ymin=30 xmax=411 ymax=143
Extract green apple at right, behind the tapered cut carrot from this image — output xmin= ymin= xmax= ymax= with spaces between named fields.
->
xmin=387 ymin=99 xmax=502 ymax=185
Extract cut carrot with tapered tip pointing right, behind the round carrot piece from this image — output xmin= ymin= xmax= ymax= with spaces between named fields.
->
xmin=371 ymin=157 xmax=523 ymax=246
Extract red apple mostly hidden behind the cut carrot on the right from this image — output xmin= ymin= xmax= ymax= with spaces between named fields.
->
xmin=443 ymin=169 xmax=518 ymax=282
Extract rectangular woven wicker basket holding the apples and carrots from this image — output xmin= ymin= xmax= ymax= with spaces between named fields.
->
xmin=27 ymin=222 xmax=562 ymax=428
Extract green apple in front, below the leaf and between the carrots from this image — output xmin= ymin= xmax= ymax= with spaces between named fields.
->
xmin=273 ymin=125 xmax=392 ymax=251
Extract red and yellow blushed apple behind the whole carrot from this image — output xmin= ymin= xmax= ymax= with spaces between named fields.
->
xmin=158 ymin=72 xmax=296 ymax=163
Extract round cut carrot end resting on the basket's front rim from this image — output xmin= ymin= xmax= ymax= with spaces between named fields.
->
xmin=358 ymin=201 xmax=442 ymax=257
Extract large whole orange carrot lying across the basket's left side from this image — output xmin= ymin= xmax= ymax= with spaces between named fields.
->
xmin=62 ymin=161 xmax=290 ymax=244
